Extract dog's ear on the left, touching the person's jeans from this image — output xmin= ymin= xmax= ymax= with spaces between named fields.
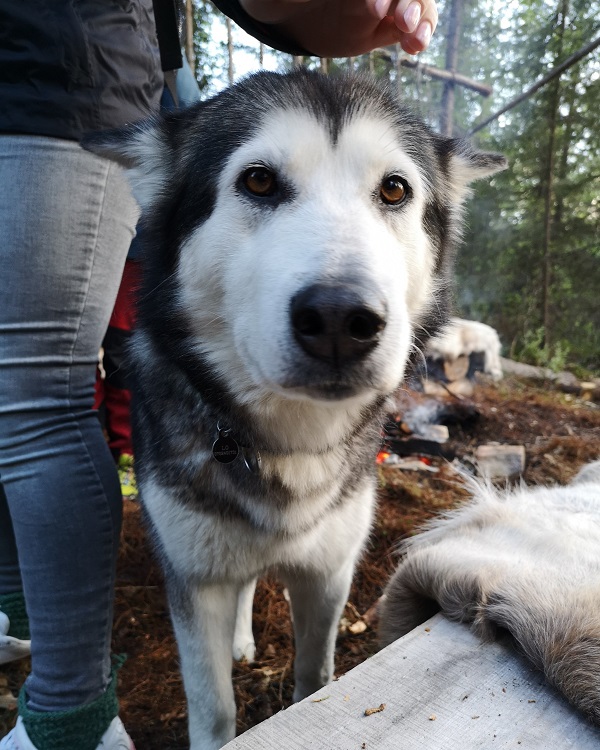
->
xmin=81 ymin=117 xmax=170 ymax=210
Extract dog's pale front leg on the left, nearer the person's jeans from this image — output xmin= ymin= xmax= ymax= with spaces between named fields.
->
xmin=169 ymin=581 xmax=238 ymax=750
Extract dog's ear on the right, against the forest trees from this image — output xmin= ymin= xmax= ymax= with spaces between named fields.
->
xmin=438 ymin=138 xmax=508 ymax=203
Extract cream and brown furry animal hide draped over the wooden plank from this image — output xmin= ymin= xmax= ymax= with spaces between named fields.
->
xmin=379 ymin=461 xmax=600 ymax=725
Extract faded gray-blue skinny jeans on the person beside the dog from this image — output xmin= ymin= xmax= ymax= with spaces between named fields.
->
xmin=0 ymin=136 xmax=137 ymax=711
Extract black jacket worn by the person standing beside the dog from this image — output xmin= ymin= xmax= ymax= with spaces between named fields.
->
xmin=0 ymin=0 xmax=303 ymax=140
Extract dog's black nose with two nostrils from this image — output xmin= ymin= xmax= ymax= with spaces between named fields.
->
xmin=290 ymin=283 xmax=386 ymax=366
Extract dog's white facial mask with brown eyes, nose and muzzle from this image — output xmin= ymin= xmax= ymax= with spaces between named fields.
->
xmin=178 ymin=109 xmax=435 ymax=406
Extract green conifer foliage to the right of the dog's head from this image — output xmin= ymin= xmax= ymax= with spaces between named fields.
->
xmin=456 ymin=0 xmax=600 ymax=370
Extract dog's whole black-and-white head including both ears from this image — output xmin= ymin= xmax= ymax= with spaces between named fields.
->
xmin=84 ymin=73 xmax=504 ymax=401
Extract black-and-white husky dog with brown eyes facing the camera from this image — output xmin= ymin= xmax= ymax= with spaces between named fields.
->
xmin=86 ymin=71 xmax=505 ymax=750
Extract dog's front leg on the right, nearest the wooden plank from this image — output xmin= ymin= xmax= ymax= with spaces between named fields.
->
xmin=286 ymin=560 xmax=354 ymax=701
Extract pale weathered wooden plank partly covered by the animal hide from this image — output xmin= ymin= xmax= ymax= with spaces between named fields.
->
xmin=225 ymin=615 xmax=600 ymax=750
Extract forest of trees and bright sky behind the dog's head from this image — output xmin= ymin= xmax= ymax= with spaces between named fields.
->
xmin=180 ymin=0 xmax=600 ymax=376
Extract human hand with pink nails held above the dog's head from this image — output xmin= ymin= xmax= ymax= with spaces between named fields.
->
xmin=240 ymin=0 xmax=438 ymax=57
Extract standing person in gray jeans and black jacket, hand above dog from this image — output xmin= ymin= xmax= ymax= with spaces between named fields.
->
xmin=0 ymin=0 xmax=436 ymax=750
